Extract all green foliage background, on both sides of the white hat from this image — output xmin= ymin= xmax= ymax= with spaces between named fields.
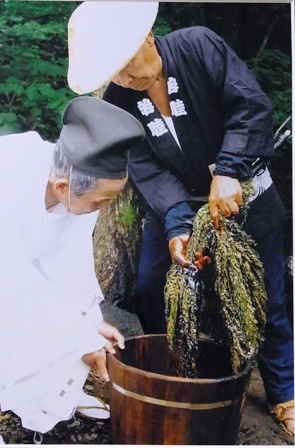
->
xmin=0 ymin=1 xmax=291 ymax=141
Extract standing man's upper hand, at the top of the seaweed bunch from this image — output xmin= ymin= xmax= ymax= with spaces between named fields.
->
xmin=209 ymin=176 xmax=243 ymax=230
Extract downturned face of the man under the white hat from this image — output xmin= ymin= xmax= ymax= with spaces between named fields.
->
xmin=112 ymin=32 xmax=162 ymax=91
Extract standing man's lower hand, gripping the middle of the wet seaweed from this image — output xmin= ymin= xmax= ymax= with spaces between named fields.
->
xmin=169 ymin=233 xmax=211 ymax=271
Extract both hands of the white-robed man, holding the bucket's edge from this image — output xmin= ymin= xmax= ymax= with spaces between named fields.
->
xmin=82 ymin=320 xmax=125 ymax=382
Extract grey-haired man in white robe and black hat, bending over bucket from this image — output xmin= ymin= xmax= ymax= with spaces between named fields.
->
xmin=0 ymin=97 xmax=144 ymax=433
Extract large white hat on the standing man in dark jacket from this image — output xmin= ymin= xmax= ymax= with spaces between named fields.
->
xmin=68 ymin=1 xmax=159 ymax=95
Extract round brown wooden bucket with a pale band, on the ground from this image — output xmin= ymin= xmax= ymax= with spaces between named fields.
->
xmin=108 ymin=335 xmax=251 ymax=445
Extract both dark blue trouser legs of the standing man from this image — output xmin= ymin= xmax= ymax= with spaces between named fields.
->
xmin=136 ymin=226 xmax=294 ymax=404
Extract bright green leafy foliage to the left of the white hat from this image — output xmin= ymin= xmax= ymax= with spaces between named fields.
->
xmin=0 ymin=1 xmax=80 ymax=141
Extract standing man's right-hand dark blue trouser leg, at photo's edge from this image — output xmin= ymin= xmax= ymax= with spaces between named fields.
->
xmin=256 ymin=226 xmax=294 ymax=404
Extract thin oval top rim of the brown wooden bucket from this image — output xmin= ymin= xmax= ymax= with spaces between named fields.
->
xmin=107 ymin=334 xmax=252 ymax=384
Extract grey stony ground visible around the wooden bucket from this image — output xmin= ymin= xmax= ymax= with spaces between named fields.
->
xmin=0 ymin=302 xmax=294 ymax=446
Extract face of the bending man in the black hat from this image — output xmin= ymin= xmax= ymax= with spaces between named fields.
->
xmin=64 ymin=176 xmax=127 ymax=215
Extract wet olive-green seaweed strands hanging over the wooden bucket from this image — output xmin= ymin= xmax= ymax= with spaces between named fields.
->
xmin=165 ymin=181 xmax=266 ymax=378
